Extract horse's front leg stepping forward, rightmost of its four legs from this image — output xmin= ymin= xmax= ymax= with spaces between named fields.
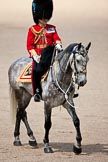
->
xmin=67 ymin=106 xmax=82 ymax=154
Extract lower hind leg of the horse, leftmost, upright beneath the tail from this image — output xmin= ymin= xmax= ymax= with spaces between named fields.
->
xmin=13 ymin=110 xmax=22 ymax=146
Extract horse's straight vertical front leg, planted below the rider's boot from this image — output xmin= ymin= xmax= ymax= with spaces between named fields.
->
xmin=43 ymin=103 xmax=53 ymax=153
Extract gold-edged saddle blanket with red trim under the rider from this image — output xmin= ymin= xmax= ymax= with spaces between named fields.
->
xmin=16 ymin=62 xmax=48 ymax=83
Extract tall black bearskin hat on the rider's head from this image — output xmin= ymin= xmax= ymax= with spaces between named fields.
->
xmin=32 ymin=0 xmax=53 ymax=24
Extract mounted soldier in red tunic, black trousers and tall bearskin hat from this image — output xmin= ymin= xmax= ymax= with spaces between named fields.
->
xmin=27 ymin=0 xmax=62 ymax=102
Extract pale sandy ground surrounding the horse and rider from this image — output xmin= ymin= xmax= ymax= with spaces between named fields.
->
xmin=0 ymin=0 xmax=108 ymax=162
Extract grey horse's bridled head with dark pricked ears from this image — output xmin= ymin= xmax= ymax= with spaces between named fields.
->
xmin=69 ymin=42 xmax=91 ymax=86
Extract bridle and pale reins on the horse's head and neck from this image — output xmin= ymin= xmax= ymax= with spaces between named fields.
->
xmin=50 ymin=45 xmax=88 ymax=108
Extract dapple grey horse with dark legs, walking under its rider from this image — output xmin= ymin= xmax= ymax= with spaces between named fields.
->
xmin=8 ymin=42 xmax=91 ymax=154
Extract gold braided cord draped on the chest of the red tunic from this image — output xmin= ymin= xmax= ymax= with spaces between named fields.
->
xmin=31 ymin=26 xmax=44 ymax=44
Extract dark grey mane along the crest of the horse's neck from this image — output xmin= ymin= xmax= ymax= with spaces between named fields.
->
xmin=56 ymin=43 xmax=78 ymax=61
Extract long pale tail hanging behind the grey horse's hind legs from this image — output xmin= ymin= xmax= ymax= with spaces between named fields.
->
xmin=9 ymin=85 xmax=17 ymax=124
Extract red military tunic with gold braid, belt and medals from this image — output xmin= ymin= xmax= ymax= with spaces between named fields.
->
xmin=27 ymin=24 xmax=61 ymax=57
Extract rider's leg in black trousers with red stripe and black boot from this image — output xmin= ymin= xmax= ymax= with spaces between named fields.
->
xmin=32 ymin=46 xmax=54 ymax=101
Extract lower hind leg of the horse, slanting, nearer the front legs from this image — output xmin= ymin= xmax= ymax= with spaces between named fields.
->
xmin=21 ymin=110 xmax=37 ymax=146
